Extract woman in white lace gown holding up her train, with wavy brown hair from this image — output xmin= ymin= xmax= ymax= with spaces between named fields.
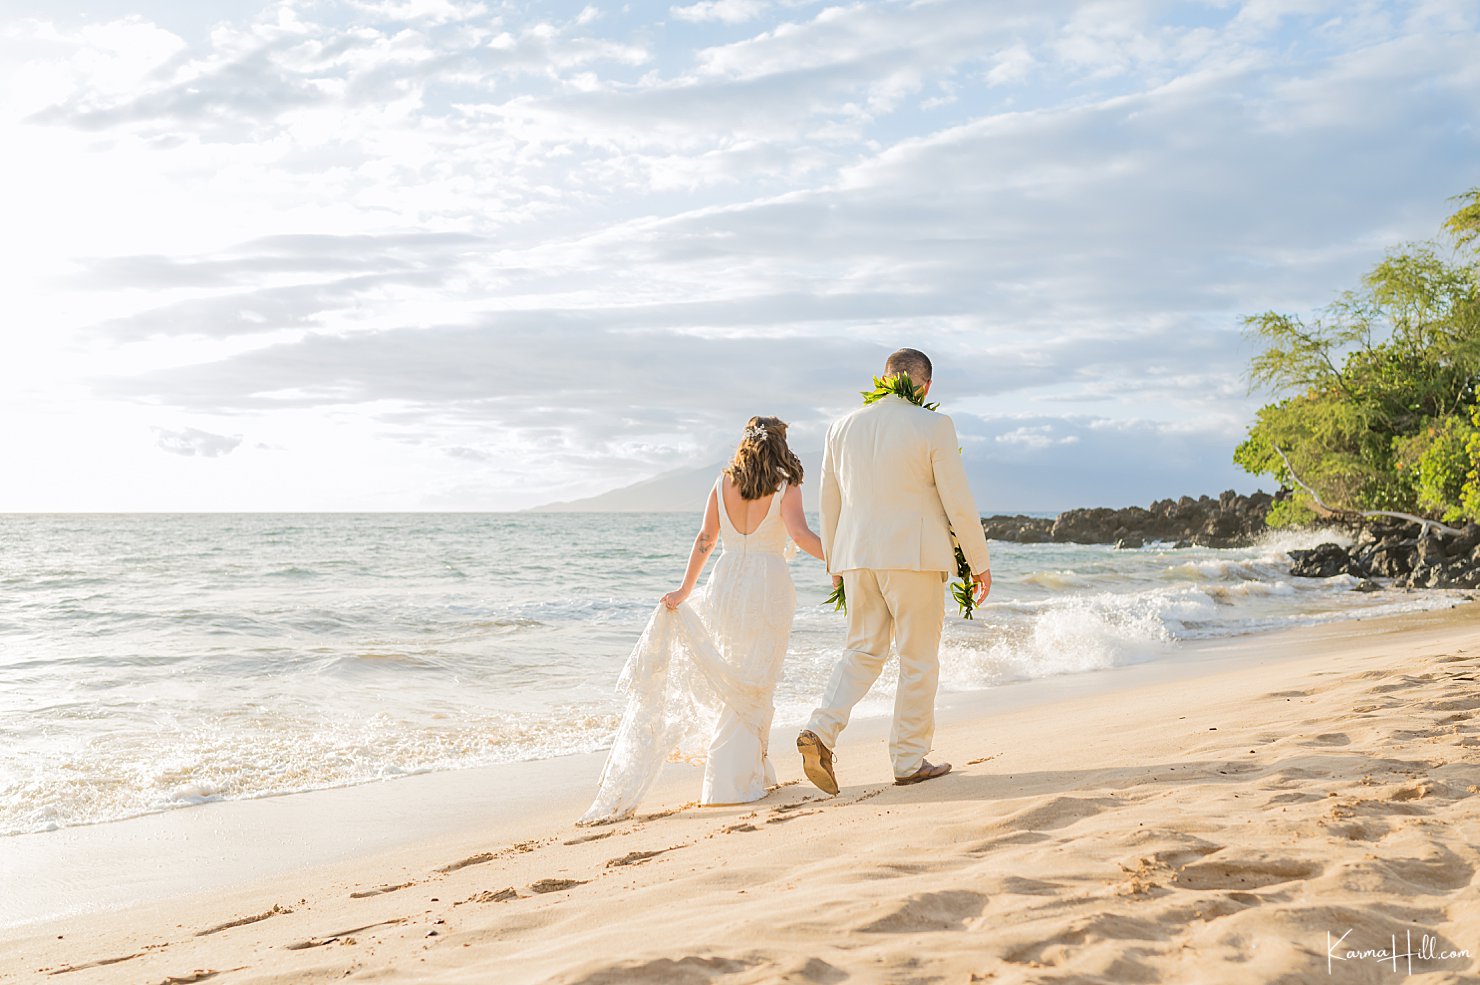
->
xmin=579 ymin=417 xmax=823 ymax=824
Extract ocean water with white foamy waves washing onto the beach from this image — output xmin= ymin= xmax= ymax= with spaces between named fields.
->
xmin=0 ymin=513 xmax=1459 ymax=836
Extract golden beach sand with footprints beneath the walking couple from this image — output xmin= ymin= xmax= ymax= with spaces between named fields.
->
xmin=0 ymin=597 xmax=1480 ymax=985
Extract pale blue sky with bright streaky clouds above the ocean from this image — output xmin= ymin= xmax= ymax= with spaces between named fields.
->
xmin=0 ymin=0 xmax=1480 ymax=513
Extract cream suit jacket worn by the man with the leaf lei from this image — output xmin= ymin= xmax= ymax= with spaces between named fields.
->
xmin=821 ymin=396 xmax=990 ymax=580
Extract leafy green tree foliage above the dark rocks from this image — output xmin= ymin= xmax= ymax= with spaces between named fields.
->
xmin=1233 ymin=188 xmax=1480 ymax=527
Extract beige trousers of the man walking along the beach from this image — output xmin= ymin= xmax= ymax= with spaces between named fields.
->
xmin=807 ymin=568 xmax=946 ymax=776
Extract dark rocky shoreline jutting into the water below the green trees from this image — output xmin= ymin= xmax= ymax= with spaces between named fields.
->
xmin=981 ymin=490 xmax=1480 ymax=590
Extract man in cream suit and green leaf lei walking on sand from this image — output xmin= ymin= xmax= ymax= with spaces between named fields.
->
xmin=796 ymin=349 xmax=992 ymax=794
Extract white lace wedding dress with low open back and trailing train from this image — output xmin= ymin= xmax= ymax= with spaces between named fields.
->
xmin=580 ymin=476 xmax=796 ymax=824
